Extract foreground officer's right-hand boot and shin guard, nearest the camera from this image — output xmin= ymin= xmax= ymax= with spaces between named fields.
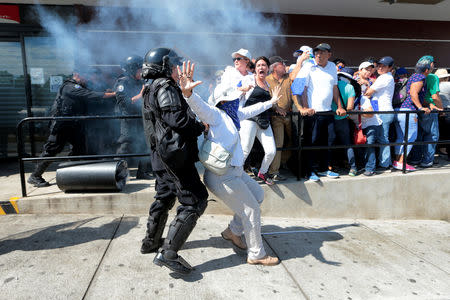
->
xmin=153 ymin=211 xmax=199 ymax=275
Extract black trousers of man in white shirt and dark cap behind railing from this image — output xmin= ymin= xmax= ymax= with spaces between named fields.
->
xmin=303 ymin=115 xmax=336 ymax=177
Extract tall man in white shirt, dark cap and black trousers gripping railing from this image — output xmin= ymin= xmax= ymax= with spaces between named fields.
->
xmin=291 ymin=43 xmax=346 ymax=181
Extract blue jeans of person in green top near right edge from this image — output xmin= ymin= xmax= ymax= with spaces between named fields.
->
xmin=411 ymin=114 xmax=439 ymax=164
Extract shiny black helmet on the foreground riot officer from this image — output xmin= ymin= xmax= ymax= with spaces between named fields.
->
xmin=142 ymin=48 xmax=183 ymax=79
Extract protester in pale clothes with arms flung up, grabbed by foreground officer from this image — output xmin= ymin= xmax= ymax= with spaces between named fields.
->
xmin=178 ymin=62 xmax=280 ymax=265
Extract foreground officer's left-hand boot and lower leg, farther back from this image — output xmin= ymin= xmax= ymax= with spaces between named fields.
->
xmin=141 ymin=212 xmax=169 ymax=254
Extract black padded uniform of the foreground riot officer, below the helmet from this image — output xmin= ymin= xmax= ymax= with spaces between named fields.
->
xmin=141 ymin=78 xmax=208 ymax=272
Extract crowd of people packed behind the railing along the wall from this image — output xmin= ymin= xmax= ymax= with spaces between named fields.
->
xmin=212 ymin=43 xmax=450 ymax=185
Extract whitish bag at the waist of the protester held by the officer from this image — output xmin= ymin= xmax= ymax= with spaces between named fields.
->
xmin=198 ymin=138 xmax=237 ymax=176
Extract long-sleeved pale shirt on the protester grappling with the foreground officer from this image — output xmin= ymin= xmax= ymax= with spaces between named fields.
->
xmin=186 ymin=93 xmax=272 ymax=167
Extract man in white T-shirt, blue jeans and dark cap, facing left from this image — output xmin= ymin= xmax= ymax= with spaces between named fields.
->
xmin=365 ymin=56 xmax=395 ymax=169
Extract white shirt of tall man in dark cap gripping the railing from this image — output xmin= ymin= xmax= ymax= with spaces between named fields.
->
xmin=297 ymin=61 xmax=337 ymax=112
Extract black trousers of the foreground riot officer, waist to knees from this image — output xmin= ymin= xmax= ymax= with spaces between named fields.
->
xmin=149 ymin=163 xmax=208 ymax=216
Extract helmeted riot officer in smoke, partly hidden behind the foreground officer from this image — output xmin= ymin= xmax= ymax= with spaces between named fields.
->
xmin=114 ymin=55 xmax=152 ymax=179
